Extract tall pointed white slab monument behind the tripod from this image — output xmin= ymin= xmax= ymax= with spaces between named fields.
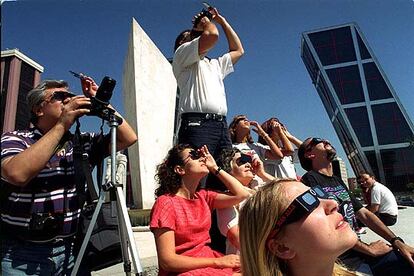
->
xmin=123 ymin=19 xmax=177 ymax=209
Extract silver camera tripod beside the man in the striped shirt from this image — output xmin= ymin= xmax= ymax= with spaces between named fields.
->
xmin=71 ymin=112 xmax=142 ymax=276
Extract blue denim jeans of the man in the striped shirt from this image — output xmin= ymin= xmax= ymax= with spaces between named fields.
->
xmin=1 ymin=236 xmax=74 ymax=276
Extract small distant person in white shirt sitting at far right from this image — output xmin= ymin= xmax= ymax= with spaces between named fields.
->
xmin=358 ymin=173 xmax=398 ymax=226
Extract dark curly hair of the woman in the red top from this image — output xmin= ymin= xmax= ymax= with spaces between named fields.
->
xmin=155 ymin=144 xmax=193 ymax=197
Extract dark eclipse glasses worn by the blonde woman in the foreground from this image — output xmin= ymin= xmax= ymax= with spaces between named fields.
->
xmin=267 ymin=186 xmax=331 ymax=240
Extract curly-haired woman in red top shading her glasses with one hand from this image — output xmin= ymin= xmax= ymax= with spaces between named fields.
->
xmin=150 ymin=144 xmax=249 ymax=276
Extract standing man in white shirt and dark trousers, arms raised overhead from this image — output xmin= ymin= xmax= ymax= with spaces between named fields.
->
xmin=172 ymin=5 xmax=244 ymax=166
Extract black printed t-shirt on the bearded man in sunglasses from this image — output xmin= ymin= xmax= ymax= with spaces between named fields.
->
xmin=302 ymin=171 xmax=363 ymax=230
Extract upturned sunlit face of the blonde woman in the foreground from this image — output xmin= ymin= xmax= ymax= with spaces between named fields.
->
xmin=280 ymin=182 xmax=357 ymax=258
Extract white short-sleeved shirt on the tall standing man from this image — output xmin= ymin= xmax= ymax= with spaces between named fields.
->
xmin=172 ymin=37 xmax=234 ymax=115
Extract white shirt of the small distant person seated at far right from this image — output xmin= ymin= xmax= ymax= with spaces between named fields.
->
xmin=371 ymin=182 xmax=398 ymax=216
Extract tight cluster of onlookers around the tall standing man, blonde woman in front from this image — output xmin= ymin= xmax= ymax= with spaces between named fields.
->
xmin=150 ymin=5 xmax=414 ymax=276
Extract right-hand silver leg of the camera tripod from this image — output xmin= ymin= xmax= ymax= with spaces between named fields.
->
xmin=116 ymin=186 xmax=142 ymax=275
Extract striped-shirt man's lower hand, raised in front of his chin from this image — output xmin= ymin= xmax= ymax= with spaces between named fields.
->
xmin=58 ymin=96 xmax=91 ymax=131
